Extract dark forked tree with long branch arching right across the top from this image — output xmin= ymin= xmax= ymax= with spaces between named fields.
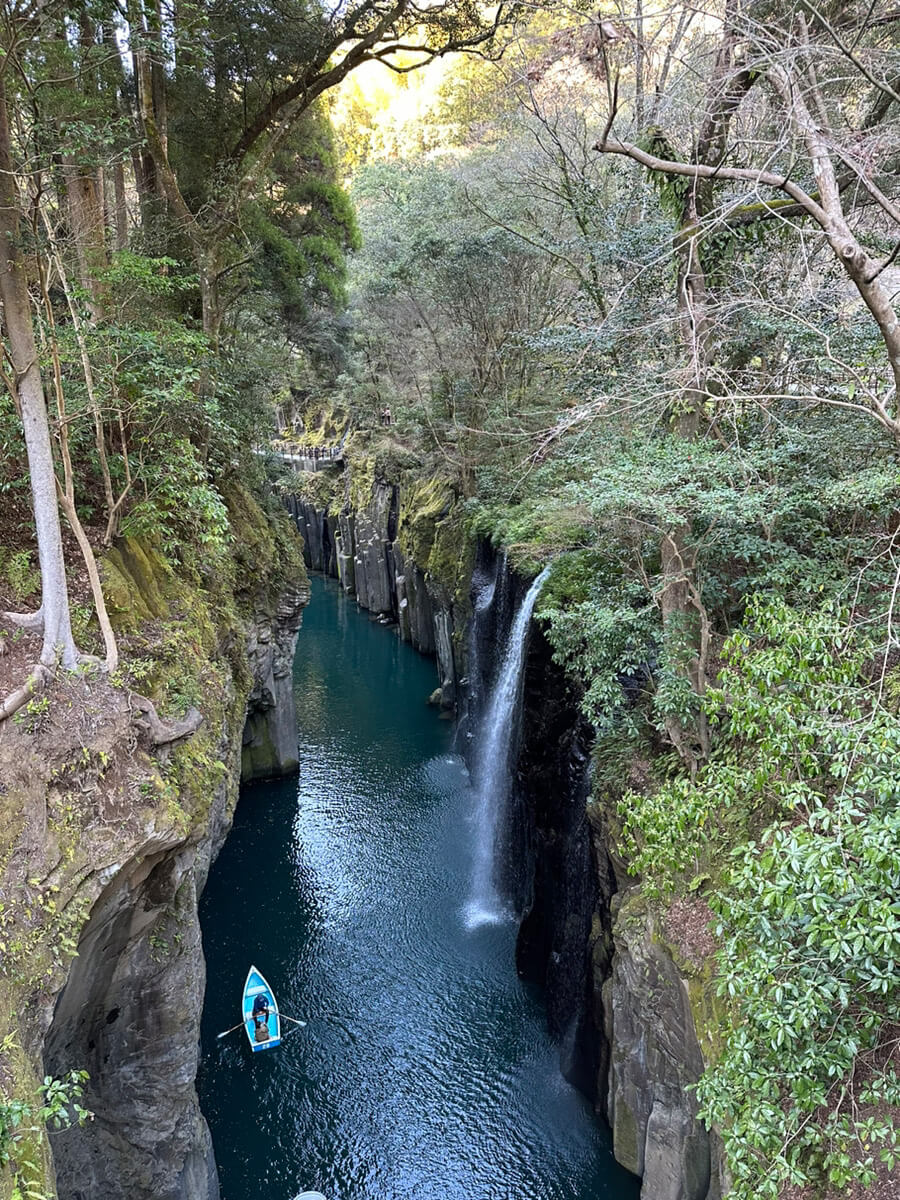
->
xmin=128 ymin=0 xmax=540 ymax=347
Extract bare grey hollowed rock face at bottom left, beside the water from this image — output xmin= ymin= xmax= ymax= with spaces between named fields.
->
xmin=43 ymin=825 xmax=226 ymax=1200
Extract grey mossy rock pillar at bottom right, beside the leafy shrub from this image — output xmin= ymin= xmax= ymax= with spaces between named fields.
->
xmin=588 ymin=782 xmax=724 ymax=1200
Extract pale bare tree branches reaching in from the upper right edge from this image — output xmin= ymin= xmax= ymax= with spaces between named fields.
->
xmin=596 ymin=0 xmax=900 ymax=440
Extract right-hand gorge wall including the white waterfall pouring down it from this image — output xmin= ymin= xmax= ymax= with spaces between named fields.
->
xmin=274 ymin=482 xmax=721 ymax=1200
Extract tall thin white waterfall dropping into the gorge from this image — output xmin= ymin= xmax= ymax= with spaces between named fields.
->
xmin=466 ymin=566 xmax=550 ymax=929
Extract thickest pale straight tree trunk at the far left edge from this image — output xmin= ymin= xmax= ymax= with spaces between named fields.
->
xmin=0 ymin=72 xmax=78 ymax=668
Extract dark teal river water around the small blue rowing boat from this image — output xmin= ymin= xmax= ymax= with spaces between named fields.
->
xmin=198 ymin=580 xmax=638 ymax=1200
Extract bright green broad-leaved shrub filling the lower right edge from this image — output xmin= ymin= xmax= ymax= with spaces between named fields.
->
xmin=622 ymin=599 xmax=900 ymax=1200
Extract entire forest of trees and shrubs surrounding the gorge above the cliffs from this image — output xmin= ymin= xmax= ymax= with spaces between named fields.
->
xmin=0 ymin=0 xmax=900 ymax=1200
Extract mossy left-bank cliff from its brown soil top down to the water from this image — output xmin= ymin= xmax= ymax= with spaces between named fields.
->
xmin=0 ymin=488 xmax=308 ymax=1200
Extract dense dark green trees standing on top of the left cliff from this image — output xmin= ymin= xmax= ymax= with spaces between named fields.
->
xmin=0 ymin=0 xmax=535 ymax=670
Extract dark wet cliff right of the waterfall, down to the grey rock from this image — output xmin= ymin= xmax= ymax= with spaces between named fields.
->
xmin=496 ymin=556 xmax=720 ymax=1200
